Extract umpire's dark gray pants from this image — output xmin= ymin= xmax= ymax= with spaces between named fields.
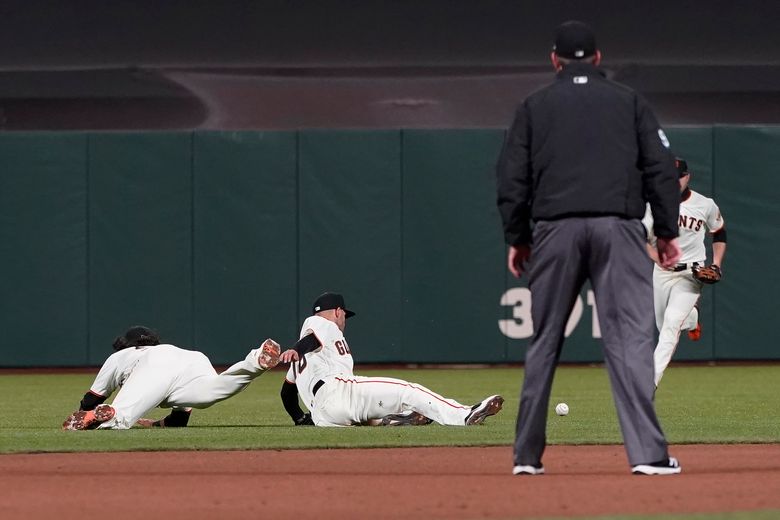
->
xmin=514 ymin=217 xmax=668 ymax=466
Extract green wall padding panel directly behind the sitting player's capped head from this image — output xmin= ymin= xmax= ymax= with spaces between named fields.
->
xmin=298 ymin=131 xmax=401 ymax=363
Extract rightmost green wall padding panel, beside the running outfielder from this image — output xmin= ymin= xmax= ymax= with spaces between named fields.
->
xmin=713 ymin=126 xmax=780 ymax=359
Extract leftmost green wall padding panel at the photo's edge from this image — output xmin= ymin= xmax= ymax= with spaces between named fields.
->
xmin=0 ymin=133 xmax=88 ymax=366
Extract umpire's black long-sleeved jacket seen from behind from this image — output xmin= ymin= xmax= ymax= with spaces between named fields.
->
xmin=497 ymin=62 xmax=680 ymax=245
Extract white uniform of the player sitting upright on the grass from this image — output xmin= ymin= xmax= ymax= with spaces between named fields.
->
xmin=286 ymin=316 xmax=471 ymax=426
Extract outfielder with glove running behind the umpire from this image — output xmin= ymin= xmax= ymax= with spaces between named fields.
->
xmin=642 ymin=157 xmax=726 ymax=386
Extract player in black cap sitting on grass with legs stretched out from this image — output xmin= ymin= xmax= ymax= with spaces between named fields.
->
xmin=279 ymin=293 xmax=504 ymax=426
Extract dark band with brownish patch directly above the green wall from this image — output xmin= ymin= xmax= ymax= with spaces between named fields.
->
xmin=0 ymin=64 xmax=780 ymax=130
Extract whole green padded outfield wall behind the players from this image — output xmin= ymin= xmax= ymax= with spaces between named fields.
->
xmin=0 ymin=126 xmax=780 ymax=367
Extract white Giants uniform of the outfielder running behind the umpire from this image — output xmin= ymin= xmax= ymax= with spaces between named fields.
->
xmin=642 ymin=190 xmax=724 ymax=386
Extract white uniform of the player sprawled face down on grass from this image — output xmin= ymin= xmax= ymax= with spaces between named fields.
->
xmin=89 ymin=344 xmax=265 ymax=430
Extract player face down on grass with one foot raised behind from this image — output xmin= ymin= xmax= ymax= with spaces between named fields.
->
xmin=62 ymin=327 xmax=280 ymax=430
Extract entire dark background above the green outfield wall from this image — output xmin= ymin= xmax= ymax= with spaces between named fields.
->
xmin=0 ymin=0 xmax=780 ymax=130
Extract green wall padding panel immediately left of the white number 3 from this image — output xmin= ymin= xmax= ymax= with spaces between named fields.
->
xmin=401 ymin=130 xmax=507 ymax=362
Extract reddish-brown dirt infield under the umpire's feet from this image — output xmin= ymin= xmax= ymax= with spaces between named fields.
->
xmin=0 ymin=444 xmax=780 ymax=520
